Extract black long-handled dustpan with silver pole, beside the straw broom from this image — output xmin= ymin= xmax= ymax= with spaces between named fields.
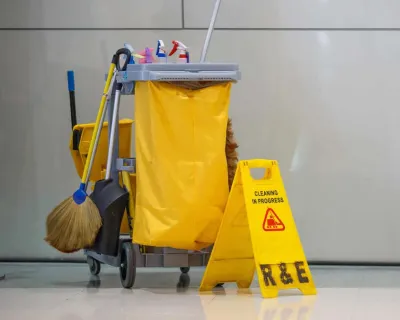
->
xmin=90 ymin=49 xmax=131 ymax=256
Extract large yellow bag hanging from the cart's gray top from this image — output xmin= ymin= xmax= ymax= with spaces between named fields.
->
xmin=133 ymin=82 xmax=231 ymax=250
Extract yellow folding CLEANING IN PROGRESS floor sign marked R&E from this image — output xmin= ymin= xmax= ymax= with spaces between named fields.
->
xmin=200 ymin=160 xmax=317 ymax=298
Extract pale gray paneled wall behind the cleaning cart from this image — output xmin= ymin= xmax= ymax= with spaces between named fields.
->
xmin=0 ymin=0 xmax=400 ymax=262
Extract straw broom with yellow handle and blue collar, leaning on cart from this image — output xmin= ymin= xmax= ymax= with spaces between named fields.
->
xmin=45 ymin=55 xmax=120 ymax=253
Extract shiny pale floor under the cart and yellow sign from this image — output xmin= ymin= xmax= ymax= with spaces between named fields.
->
xmin=0 ymin=264 xmax=400 ymax=320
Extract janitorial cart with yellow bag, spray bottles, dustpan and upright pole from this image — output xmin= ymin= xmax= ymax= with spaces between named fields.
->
xmin=47 ymin=0 xmax=240 ymax=288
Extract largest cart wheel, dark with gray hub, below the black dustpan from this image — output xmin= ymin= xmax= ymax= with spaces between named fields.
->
xmin=119 ymin=242 xmax=136 ymax=289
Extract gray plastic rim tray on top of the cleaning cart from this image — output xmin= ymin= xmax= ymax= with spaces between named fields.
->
xmin=117 ymin=63 xmax=241 ymax=83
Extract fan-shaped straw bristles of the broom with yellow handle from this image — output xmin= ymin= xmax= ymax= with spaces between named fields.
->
xmin=45 ymin=197 xmax=102 ymax=253
